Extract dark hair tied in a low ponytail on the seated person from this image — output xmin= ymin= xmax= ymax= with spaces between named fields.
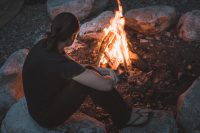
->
xmin=47 ymin=12 xmax=80 ymax=51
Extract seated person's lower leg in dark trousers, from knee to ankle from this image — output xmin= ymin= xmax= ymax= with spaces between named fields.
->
xmin=89 ymin=88 xmax=132 ymax=128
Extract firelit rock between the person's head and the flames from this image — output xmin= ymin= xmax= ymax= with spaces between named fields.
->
xmin=79 ymin=11 xmax=114 ymax=40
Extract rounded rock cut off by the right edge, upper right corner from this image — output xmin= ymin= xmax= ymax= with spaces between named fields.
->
xmin=177 ymin=10 xmax=200 ymax=41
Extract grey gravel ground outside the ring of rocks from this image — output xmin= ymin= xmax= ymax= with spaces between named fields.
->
xmin=0 ymin=0 xmax=200 ymax=65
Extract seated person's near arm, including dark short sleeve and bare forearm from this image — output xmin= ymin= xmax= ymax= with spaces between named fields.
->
xmin=59 ymin=58 xmax=114 ymax=91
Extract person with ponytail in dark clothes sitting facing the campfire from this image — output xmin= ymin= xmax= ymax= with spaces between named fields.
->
xmin=22 ymin=13 xmax=149 ymax=129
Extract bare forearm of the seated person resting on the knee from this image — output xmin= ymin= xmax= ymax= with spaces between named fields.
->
xmin=73 ymin=69 xmax=114 ymax=91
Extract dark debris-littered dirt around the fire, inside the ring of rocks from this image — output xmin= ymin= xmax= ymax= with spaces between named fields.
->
xmin=71 ymin=27 xmax=200 ymax=133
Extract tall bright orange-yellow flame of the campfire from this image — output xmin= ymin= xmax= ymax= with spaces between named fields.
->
xmin=100 ymin=0 xmax=131 ymax=70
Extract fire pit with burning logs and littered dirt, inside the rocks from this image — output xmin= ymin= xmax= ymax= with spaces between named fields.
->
xmin=62 ymin=0 xmax=200 ymax=132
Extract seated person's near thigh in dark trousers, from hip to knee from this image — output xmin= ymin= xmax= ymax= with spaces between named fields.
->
xmin=40 ymin=80 xmax=88 ymax=128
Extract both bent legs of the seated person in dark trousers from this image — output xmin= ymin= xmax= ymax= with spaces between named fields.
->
xmin=40 ymin=80 xmax=131 ymax=128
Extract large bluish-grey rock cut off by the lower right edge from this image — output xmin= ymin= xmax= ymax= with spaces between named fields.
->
xmin=177 ymin=77 xmax=200 ymax=133
